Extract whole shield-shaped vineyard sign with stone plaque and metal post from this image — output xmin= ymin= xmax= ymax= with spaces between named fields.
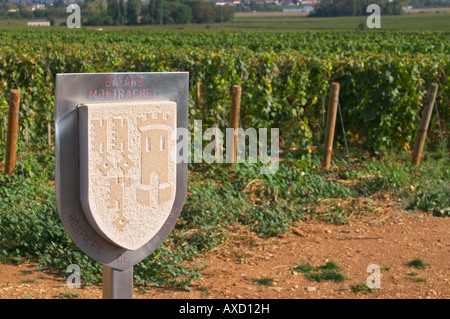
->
xmin=55 ymin=72 xmax=189 ymax=299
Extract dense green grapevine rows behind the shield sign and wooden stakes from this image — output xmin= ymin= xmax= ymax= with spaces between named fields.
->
xmin=0 ymin=31 xmax=450 ymax=152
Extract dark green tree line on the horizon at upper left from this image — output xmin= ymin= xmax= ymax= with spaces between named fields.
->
xmin=0 ymin=0 xmax=235 ymax=26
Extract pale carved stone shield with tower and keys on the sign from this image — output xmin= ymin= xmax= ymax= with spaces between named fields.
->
xmin=80 ymin=101 xmax=176 ymax=249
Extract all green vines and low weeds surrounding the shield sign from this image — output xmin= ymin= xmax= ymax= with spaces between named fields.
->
xmin=0 ymin=30 xmax=450 ymax=296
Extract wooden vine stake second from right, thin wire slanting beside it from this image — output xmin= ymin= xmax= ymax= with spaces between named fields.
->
xmin=322 ymin=82 xmax=340 ymax=170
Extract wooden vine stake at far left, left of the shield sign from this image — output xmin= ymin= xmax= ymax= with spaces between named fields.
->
xmin=4 ymin=89 xmax=20 ymax=176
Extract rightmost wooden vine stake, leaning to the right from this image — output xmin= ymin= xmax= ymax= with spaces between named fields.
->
xmin=411 ymin=83 xmax=438 ymax=165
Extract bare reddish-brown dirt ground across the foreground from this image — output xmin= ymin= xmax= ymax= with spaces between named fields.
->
xmin=0 ymin=210 xmax=450 ymax=299
